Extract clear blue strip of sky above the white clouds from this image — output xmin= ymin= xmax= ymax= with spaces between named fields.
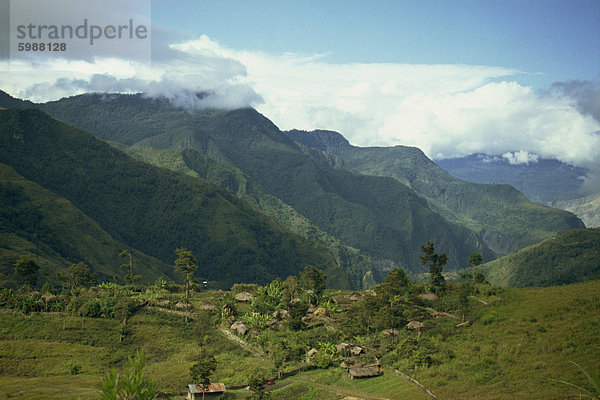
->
xmin=152 ymin=0 xmax=600 ymax=86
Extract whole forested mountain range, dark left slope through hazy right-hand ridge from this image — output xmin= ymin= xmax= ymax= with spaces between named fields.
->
xmin=0 ymin=93 xmax=583 ymax=287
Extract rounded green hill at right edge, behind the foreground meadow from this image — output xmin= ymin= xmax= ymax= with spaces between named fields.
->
xmin=481 ymin=228 xmax=600 ymax=287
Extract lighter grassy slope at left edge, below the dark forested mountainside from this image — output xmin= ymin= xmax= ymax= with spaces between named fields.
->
xmin=0 ymin=164 xmax=172 ymax=283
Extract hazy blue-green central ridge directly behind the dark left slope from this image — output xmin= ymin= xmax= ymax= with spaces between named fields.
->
xmin=14 ymin=95 xmax=492 ymax=272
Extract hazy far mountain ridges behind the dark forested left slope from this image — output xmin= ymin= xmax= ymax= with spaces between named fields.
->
xmin=0 ymin=94 xmax=582 ymax=284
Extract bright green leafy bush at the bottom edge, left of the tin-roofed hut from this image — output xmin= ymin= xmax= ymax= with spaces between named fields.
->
xmin=101 ymin=351 xmax=158 ymax=400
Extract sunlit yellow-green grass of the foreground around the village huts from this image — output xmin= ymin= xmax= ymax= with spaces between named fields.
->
xmin=0 ymin=281 xmax=600 ymax=400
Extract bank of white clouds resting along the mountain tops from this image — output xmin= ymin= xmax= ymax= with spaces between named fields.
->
xmin=0 ymin=34 xmax=600 ymax=186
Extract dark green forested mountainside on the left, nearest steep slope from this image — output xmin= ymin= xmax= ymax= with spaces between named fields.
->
xmin=0 ymin=109 xmax=349 ymax=287
